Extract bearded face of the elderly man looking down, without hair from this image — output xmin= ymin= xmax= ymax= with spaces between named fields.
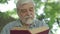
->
xmin=18 ymin=3 xmax=34 ymax=24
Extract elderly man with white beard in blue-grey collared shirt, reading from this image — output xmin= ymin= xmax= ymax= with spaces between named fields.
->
xmin=1 ymin=0 xmax=48 ymax=34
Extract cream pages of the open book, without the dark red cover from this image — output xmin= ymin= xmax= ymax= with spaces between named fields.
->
xmin=12 ymin=26 xmax=49 ymax=34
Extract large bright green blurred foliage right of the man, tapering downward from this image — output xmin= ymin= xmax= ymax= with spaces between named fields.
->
xmin=45 ymin=2 xmax=60 ymax=28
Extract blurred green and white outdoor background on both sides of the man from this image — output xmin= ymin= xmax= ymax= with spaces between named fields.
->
xmin=0 ymin=0 xmax=60 ymax=34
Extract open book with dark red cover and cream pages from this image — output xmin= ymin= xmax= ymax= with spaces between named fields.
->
xmin=10 ymin=26 xmax=49 ymax=34
